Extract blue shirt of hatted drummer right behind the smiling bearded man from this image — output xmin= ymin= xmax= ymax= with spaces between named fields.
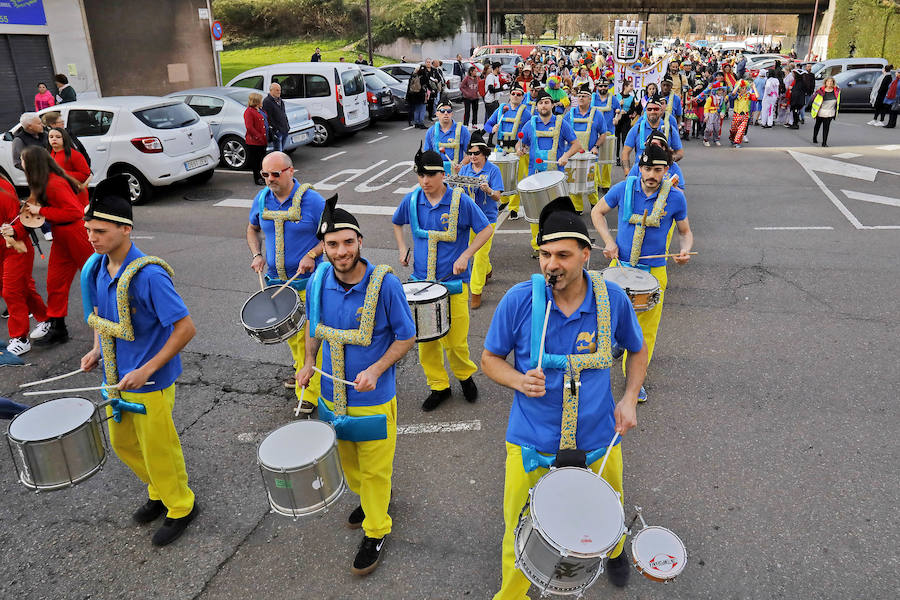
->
xmin=391 ymin=187 xmax=490 ymax=283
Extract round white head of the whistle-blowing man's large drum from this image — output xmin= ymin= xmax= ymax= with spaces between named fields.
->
xmin=531 ymin=467 xmax=625 ymax=554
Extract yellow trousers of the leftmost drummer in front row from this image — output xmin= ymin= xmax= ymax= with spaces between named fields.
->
xmin=106 ymin=383 xmax=194 ymax=519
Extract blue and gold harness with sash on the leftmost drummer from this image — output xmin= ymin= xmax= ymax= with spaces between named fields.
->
xmin=81 ymin=254 xmax=175 ymax=423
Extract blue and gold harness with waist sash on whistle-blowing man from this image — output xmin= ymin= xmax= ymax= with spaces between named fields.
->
xmin=522 ymin=271 xmax=613 ymax=473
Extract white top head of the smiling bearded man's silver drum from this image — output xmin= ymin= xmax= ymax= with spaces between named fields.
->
xmin=257 ymin=421 xmax=337 ymax=470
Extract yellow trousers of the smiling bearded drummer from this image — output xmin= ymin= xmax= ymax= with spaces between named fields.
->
xmin=323 ymin=396 xmax=397 ymax=538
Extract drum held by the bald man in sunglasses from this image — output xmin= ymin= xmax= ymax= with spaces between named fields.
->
xmin=241 ymin=285 xmax=306 ymax=344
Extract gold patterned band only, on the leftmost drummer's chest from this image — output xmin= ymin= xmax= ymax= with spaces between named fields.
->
xmin=88 ymin=256 xmax=175 ymax=399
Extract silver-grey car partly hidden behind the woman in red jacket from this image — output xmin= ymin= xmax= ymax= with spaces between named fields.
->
xmin=167 ymin=87 xmax=316 ymax=170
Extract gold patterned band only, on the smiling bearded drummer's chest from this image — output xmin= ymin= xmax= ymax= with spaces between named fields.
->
xmin=315 ymin=265 xmax=394 ymax=416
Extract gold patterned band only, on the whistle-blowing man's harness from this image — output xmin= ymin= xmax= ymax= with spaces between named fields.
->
xmin=559 ymin=271 xmax=613 ymax=450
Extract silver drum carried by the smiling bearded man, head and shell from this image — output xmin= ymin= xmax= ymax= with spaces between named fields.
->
xmin=256 ymin=420 xmax=344 ymax=519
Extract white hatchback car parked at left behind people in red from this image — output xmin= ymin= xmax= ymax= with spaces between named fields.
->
xmin=0 ymin=96 xmax=219 ymax=204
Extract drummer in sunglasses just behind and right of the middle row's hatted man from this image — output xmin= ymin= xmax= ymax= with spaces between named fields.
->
xmin=459 ymin=133 xmax=503 ymax=309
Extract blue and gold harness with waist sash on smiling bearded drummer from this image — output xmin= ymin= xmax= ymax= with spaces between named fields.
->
xmin=306 ymin=263 xmax=393 ymax=442
